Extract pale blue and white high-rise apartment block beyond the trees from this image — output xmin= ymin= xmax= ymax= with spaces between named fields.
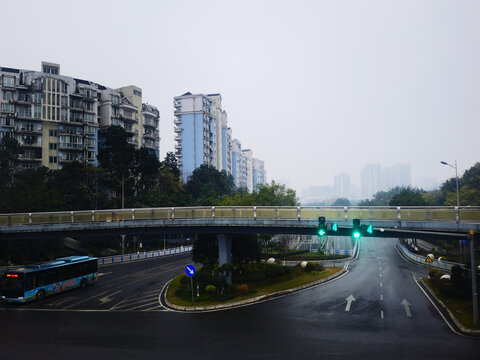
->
xmin=173 ymin=92 xmax=266 ymax=191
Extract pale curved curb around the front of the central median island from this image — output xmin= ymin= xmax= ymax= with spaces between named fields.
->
xmin=162 ymin=268 xmax=347 ymax=312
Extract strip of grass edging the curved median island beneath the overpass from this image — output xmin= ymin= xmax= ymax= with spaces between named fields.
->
xmin=166 ymin=267 xmax=343 ymax=306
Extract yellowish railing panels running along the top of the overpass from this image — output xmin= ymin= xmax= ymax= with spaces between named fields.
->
xmin=0 ymin=206 xmax=480 ymax=227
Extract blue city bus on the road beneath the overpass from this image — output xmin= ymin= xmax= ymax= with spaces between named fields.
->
xmin=2 ymin=256 xmax=98 ymax=303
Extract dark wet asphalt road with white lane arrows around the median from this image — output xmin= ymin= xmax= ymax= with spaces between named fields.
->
xmin=0 ymin=238 xmax=480 ymax=359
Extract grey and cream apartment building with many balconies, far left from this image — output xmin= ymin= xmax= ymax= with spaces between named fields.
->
xmin=0 ymin=62 xmax=160 ymax=169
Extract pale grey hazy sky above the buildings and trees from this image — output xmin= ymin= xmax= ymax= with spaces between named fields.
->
xmin=0 ymin=0 xmax=480 ymax=194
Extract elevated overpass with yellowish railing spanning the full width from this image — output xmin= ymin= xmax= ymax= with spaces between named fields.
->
xmin=0 ymin=206 xmax=480 ymax=239
